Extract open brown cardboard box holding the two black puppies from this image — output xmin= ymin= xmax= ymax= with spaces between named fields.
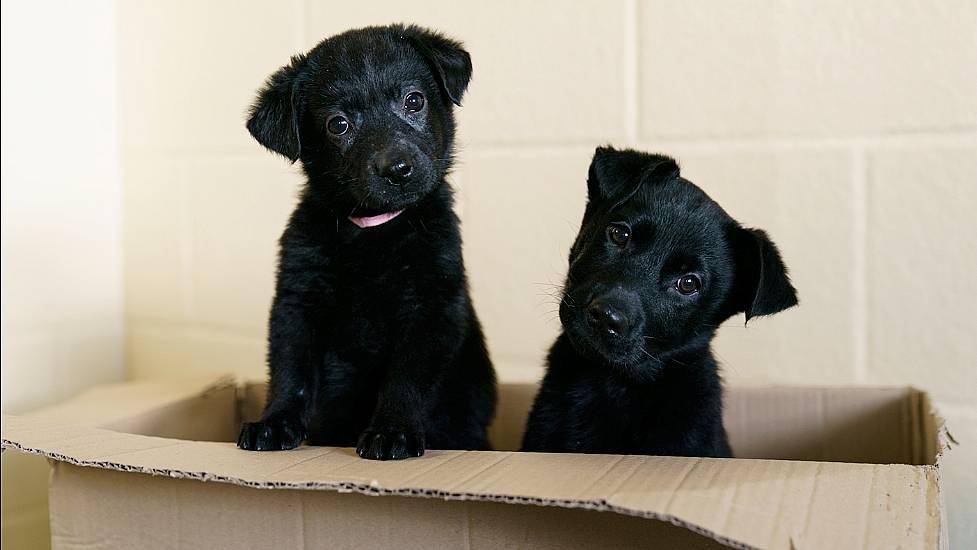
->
xmin=3 ymin=379 xmax=947 ymax=550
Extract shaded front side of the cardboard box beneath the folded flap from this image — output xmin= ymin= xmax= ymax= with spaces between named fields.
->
xmin=45 ymin=462 xmax=724 ymax=550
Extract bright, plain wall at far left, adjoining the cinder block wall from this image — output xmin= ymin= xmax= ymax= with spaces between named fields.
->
xmin=0 ymin=0 xmax=124 ymax=549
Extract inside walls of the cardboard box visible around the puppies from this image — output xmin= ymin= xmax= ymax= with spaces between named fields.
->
xmin=133 ymin=382 xmax=939 ymax=465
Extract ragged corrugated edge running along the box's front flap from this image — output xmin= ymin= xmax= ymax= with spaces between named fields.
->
xmin=0 ymin=438 xmax=759 ymax=550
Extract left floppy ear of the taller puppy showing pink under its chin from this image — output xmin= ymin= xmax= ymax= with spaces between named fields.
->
xmin=247 ymin=55 xmax=306 ymax=162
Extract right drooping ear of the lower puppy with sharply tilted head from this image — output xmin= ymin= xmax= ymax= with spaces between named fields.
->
xmin=730 ymin=226 xmax=797 ymax=321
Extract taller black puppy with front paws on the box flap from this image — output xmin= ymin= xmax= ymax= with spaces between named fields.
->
xmin=238 ymin=25 xmax=495 ymax=460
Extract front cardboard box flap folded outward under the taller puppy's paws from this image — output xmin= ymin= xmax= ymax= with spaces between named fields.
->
xmin=2 ymin=415 xmax=941 ymax=549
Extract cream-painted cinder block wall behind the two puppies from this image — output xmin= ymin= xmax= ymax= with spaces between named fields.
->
xmin=119 ymin=0 xmax=977 ymax=547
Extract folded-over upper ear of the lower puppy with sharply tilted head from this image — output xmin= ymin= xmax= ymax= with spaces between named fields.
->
xmin=587 ymin=147 xmax=679 ymax=204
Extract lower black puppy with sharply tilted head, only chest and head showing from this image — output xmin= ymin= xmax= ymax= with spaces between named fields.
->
xmin=523 ymin=148 xmax=797 ymax=457
